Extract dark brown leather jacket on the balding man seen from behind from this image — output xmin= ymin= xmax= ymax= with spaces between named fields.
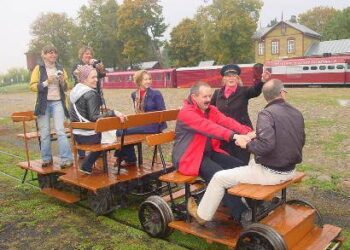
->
xmin=247 ymin=99 xmax=305 ymax=172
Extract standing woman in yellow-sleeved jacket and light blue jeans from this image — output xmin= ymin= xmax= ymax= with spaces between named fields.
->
xmin=30 ymin=45 xmax=73 ymax=168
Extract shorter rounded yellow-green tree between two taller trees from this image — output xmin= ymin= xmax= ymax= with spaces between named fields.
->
xmin=168 ymin=18 xmax=204 ymax=67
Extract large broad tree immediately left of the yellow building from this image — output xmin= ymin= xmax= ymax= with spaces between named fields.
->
xmin=196 ymin=0 xmax=262 ymax=64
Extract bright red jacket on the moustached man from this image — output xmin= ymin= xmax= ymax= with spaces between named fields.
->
xmin=172 ymin=100 xmax=252 ymax=176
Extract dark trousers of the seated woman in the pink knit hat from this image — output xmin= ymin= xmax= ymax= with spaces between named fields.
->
xmin=74 ymin=134 xmax=101 ymax=172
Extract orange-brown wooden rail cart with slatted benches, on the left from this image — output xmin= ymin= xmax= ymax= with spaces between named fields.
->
xmin=12 ymin=110 xmax=178 ymax=215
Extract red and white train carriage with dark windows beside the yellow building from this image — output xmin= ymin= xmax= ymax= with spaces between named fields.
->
xmin=264 ymin=55 xmax=350 ymax=86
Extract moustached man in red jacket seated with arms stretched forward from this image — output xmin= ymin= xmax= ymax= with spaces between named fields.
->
xmin=172 ymin=82 xmax=252 ymax=221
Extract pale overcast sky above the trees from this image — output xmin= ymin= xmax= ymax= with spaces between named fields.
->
xmin=0 ymin=0 xmax=350 ymax=73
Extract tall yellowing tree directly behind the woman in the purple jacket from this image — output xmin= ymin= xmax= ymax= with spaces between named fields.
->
xmin=118 ymin=0 xmax=166 ymax=66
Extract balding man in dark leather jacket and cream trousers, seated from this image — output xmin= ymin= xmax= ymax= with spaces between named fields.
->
xmin=188 ymin=79 xmax=305 ymax=227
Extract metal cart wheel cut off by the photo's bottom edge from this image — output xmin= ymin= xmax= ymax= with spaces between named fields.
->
xmin=235 ymin=223 xmax=287 ymax=250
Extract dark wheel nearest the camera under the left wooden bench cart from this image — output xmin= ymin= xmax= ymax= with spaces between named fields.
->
xmin=88 ymin=188 xmax=114 ymax=215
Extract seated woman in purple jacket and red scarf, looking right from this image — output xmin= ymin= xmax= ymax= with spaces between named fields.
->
xmin=115 ymin=70 xmax=167 ymax=165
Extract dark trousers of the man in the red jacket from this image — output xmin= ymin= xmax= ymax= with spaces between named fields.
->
xmin=199 ymin=151 xmax=247 ymax=221
